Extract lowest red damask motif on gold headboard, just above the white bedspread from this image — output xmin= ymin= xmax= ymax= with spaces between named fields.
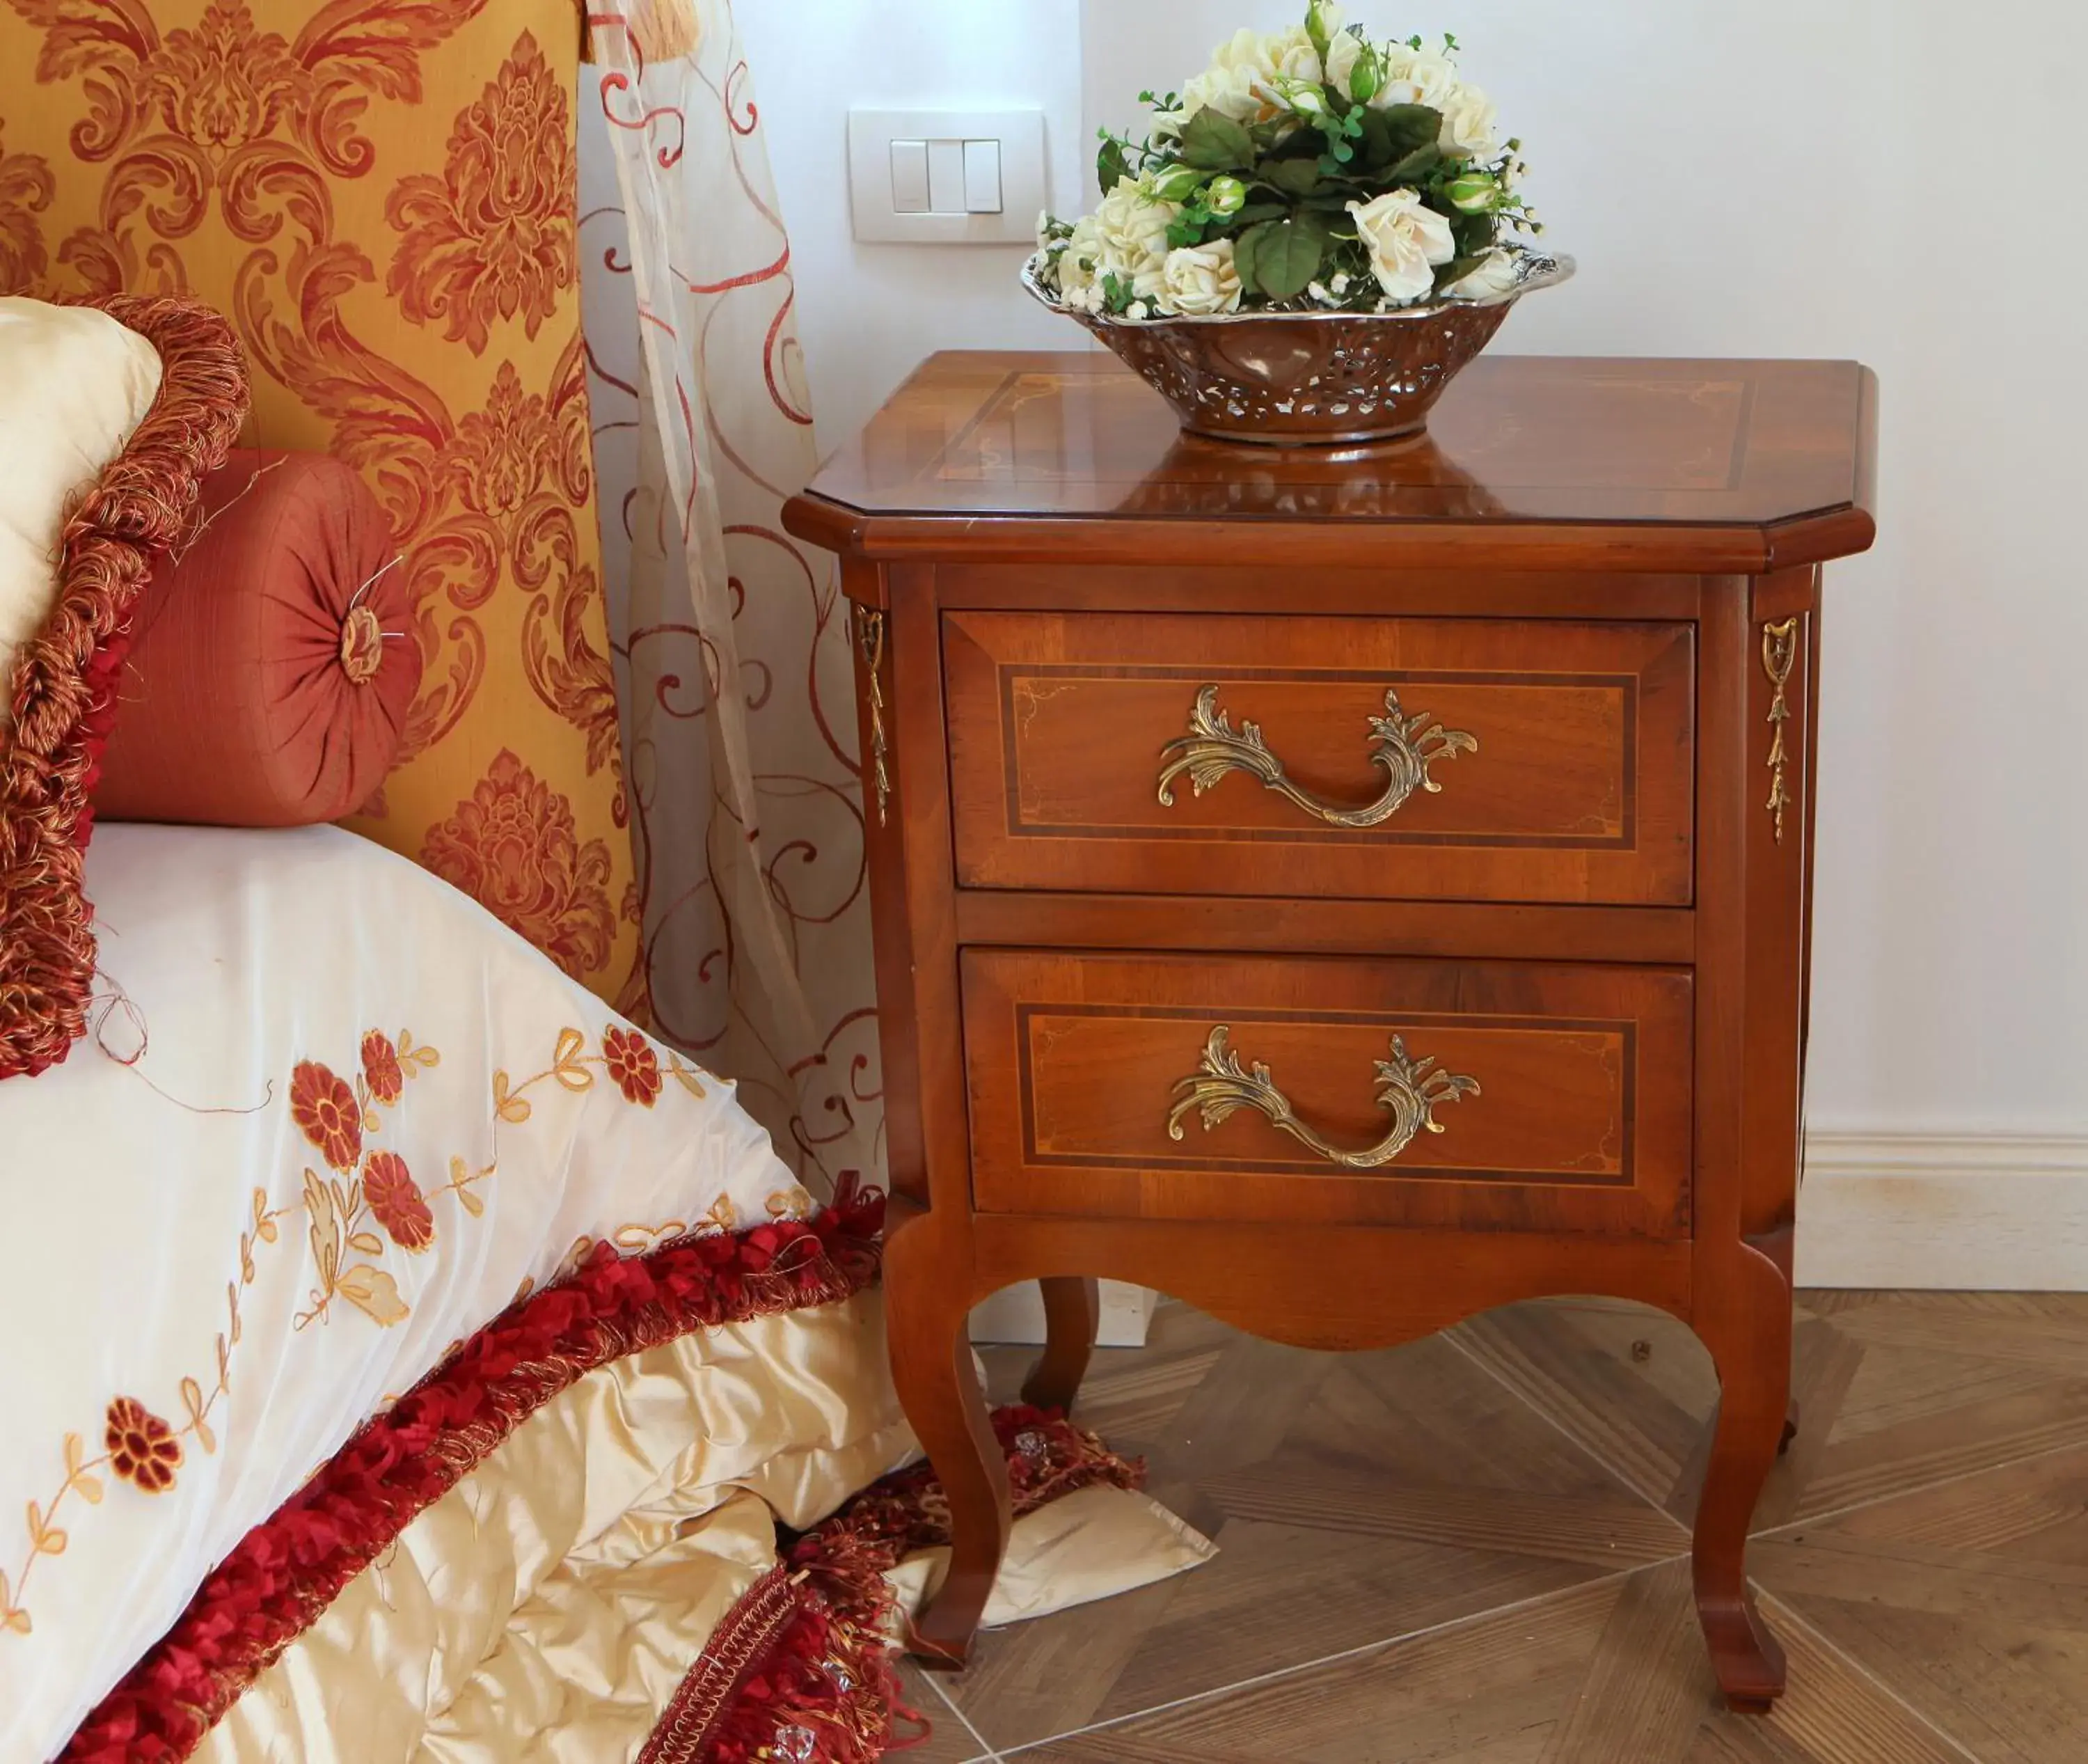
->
xmin=420 ymin=748 xmax=616 ymax=979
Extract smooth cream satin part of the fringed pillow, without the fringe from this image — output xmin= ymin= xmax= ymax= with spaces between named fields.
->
xmin=0 ymin=297 xmax=161 ymax=729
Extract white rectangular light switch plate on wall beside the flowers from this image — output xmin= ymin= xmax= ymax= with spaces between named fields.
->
xmin=848 ymin=111 xmax=1046 ymax=244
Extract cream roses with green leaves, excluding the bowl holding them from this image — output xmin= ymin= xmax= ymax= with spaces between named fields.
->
xmin=1031 ymin=0 xmax=1543 ymax=320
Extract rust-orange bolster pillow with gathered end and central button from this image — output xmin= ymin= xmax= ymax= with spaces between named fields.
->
xmin=94 ymin=449 xmax=420 ymax=827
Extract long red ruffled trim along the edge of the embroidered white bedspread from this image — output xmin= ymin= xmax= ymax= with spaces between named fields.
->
xmin=61 ymin=1181 xmax=885 ymax=1764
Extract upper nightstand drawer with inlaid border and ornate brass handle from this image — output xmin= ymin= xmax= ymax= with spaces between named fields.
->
xmin=944 ymin=612 xmax=1695 ymax=906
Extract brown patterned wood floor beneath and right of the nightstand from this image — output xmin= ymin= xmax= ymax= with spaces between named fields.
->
xmin=908 ymin=1292 xmax=2088 ymax=1764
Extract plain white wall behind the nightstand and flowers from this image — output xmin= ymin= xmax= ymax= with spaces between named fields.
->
xmin=741 ymin=0 xmax=2088 ymax=1169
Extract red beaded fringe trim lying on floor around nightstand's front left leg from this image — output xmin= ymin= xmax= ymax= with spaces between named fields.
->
xmin=639 ymin=1407 xmax=1144 ymax=1764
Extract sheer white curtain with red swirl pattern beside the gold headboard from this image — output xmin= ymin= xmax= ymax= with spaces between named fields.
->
xmin=580 ymin=0 xmax=883 ymax=1192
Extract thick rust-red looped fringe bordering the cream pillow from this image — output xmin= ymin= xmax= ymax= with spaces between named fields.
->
xmin=0 ymin=294 xmax=246 ymax=1079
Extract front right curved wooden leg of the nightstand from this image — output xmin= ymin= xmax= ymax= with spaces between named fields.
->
xmin=1691 ymin=1246 xmax=1792 ymax=1714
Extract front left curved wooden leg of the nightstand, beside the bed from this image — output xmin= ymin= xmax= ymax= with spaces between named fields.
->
xmin=885 ymin=1219 xmax=1013 ymax=1670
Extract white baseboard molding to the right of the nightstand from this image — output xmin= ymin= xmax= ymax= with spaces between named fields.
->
xmin=1798 ymin=1133 xmax=2088 ymax=1292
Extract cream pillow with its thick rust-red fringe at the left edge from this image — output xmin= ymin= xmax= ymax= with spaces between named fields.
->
xmin=0 ymin=294 xmax=246 ymax=1079
